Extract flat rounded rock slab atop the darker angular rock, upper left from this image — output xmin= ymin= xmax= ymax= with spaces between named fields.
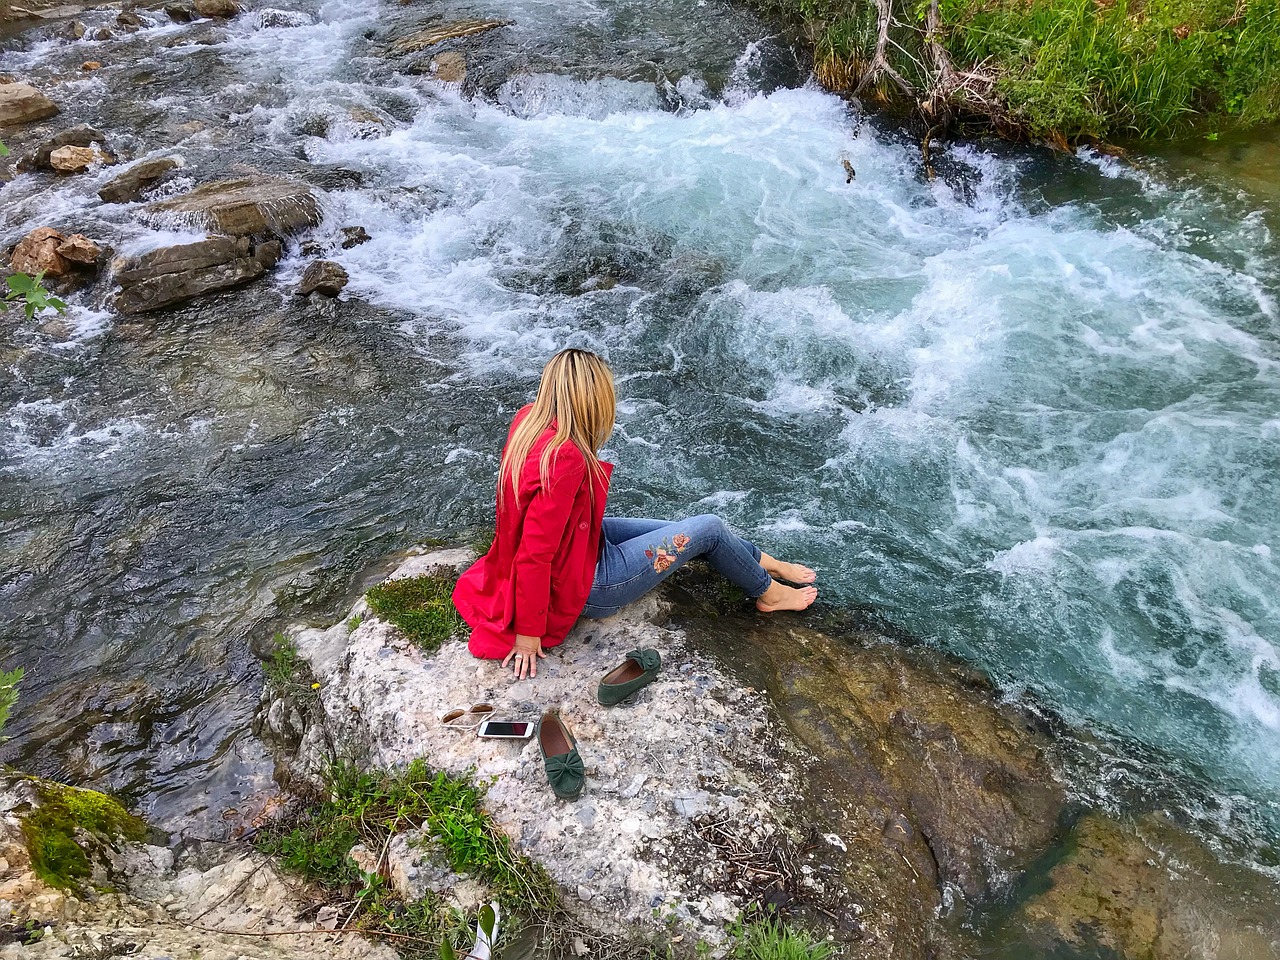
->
xmin=147 ymin=177 xmax=320 ymax=237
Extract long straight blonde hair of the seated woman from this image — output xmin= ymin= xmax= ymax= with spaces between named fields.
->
xmin=498 ymin=348 xmax=617 ymax=512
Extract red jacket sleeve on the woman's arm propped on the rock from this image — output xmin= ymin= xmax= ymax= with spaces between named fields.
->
xmin=512 ymin=442 xmax=586 ymax=639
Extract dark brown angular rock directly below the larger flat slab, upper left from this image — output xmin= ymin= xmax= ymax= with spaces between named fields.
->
xmin=115 ymin=237 xmax=266 ymax=314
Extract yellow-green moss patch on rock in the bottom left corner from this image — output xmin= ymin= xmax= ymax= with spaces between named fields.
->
xmin=22 ymin=781 xmax=147 ymax=890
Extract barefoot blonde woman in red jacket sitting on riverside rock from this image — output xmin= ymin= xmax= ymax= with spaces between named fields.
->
xmin=453 ymin=349 xmax=818 ymax=678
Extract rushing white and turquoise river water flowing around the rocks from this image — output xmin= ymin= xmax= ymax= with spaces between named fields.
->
xmin=0 ymin=0 xmax=1280 ymax=901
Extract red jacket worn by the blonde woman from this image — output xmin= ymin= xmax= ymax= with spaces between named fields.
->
xmin=453 ymin=407 xmax=613 ymax=659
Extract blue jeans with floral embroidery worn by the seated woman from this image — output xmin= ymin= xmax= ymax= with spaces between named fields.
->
xmin=582 ymin=513 xmax=772 ymax=620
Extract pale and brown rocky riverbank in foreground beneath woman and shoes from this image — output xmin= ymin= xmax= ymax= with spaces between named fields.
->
xmin=0 ymin=550 xmax=1280 ymax=960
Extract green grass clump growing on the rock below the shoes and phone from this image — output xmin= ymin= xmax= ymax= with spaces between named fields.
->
xmin=256 ymin=760 xmax=557 ymax=956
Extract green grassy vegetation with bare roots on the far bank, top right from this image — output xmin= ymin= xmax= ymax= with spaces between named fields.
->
xmin=758 ymin=0 xmax=1280 ymax=148
